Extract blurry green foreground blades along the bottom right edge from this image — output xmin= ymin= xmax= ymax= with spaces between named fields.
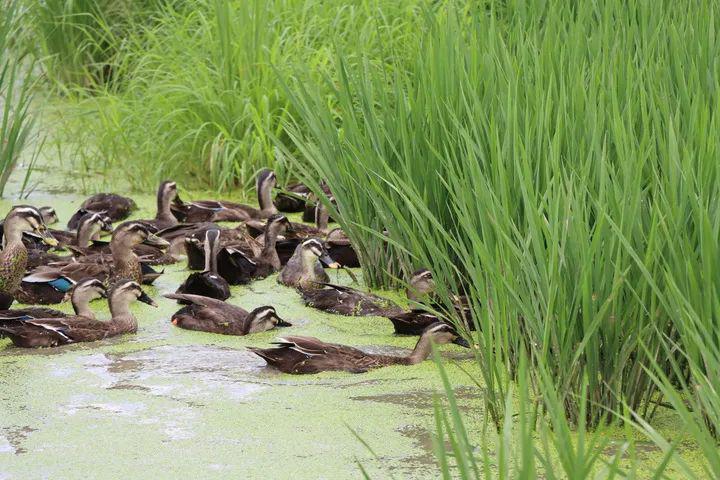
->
xmin=433 ymin=353 xmax=698 ymax=480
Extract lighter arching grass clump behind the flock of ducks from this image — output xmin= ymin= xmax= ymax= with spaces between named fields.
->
xmin=56 ymin=0 xmax=424 ymax=190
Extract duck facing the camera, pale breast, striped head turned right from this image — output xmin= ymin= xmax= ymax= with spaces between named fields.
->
xmin=278 ymin=238 xmax=340 ymax=288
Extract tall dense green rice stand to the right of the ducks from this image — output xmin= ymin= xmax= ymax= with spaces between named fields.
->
xmin=286 ymin=1 xmax=720 ymax=454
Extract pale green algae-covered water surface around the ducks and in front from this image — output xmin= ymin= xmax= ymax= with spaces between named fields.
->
xmin=0 ymin=166 xmax=479 ymax=480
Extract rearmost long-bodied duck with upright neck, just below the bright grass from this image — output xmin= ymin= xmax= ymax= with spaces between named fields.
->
xmin=173 ymin=169 xmax=278 ymax=223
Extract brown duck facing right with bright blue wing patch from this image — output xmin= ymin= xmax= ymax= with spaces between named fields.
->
xmin=17 ymin=221 xmax=167 ymax=304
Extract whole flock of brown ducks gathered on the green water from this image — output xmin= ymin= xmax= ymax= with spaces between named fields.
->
xmin=0 ymin=170 xmax=468 ymax=374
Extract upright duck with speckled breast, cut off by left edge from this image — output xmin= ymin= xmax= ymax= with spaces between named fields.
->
xmin=0 ymin=205 xmax=57 ymax=310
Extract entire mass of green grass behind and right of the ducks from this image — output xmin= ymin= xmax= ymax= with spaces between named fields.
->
xmin=19 ymin=0 xmax=720 ymax=478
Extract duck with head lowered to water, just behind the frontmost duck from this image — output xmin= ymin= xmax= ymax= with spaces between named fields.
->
xmin=164 ymin=293 xmax=292 ymax=335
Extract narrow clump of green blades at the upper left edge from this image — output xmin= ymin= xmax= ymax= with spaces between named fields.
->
xmin=0 ymin=0 xmax=34 ymax=196
